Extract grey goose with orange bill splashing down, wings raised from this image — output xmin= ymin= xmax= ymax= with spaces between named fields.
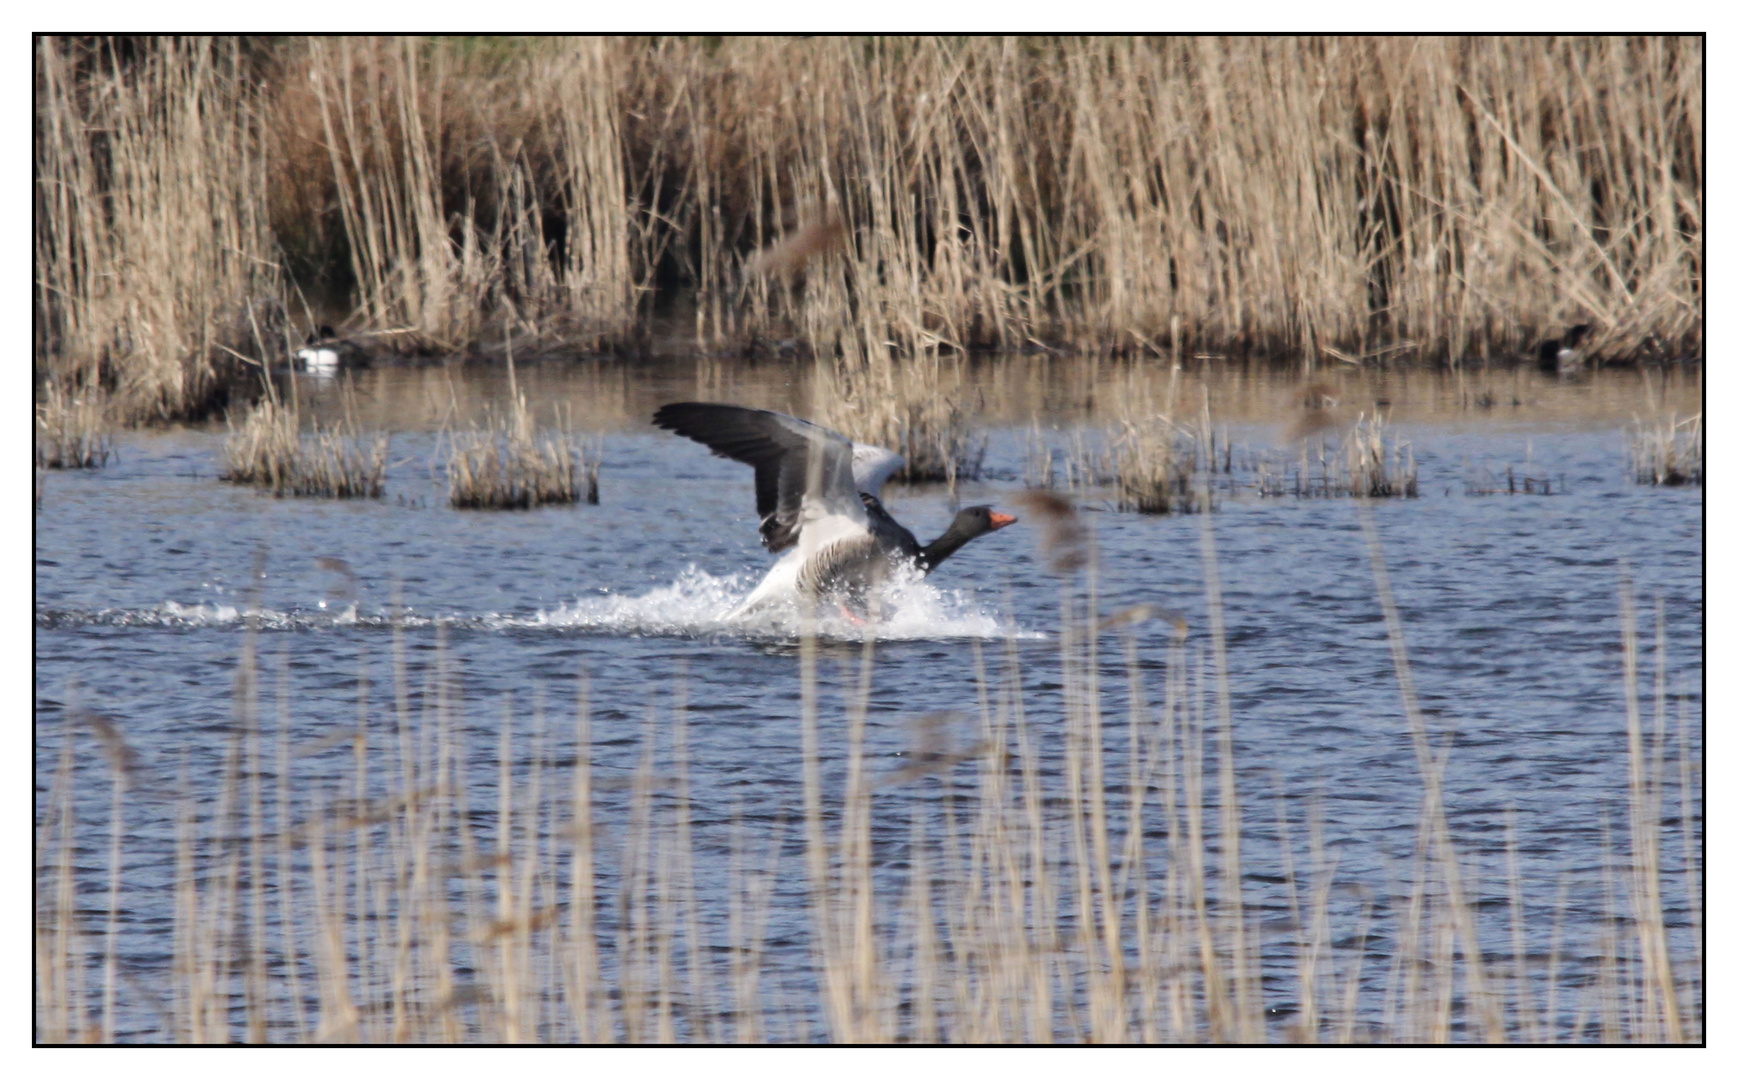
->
xmin=652 ymin=402 xmax=1018 ymax=617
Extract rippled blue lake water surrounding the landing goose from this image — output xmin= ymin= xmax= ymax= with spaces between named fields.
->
xmin=35 ymin=357 xmax=1703 ymax=1042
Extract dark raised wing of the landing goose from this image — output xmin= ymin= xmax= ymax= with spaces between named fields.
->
xmin=652 ymin=402 xmax=855 ymax=551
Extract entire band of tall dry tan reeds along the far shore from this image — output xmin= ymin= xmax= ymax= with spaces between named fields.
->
xmin=35 ymin=37 xmax=1703 ymax=438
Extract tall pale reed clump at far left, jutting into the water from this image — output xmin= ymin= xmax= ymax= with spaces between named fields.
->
xmin=33 ymin=37 xmax=285 ymax=423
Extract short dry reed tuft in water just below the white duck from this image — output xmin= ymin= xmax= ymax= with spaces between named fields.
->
xmin=219 ymin=398 xmax=391 ymax=499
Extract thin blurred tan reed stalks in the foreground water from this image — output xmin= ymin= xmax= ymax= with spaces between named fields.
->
xmin=35 ymin=511 xmax=1702 ymax=1043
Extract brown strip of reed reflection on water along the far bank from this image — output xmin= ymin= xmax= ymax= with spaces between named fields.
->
xmin=274 ymin=357 xmax=1702 ymax=431
